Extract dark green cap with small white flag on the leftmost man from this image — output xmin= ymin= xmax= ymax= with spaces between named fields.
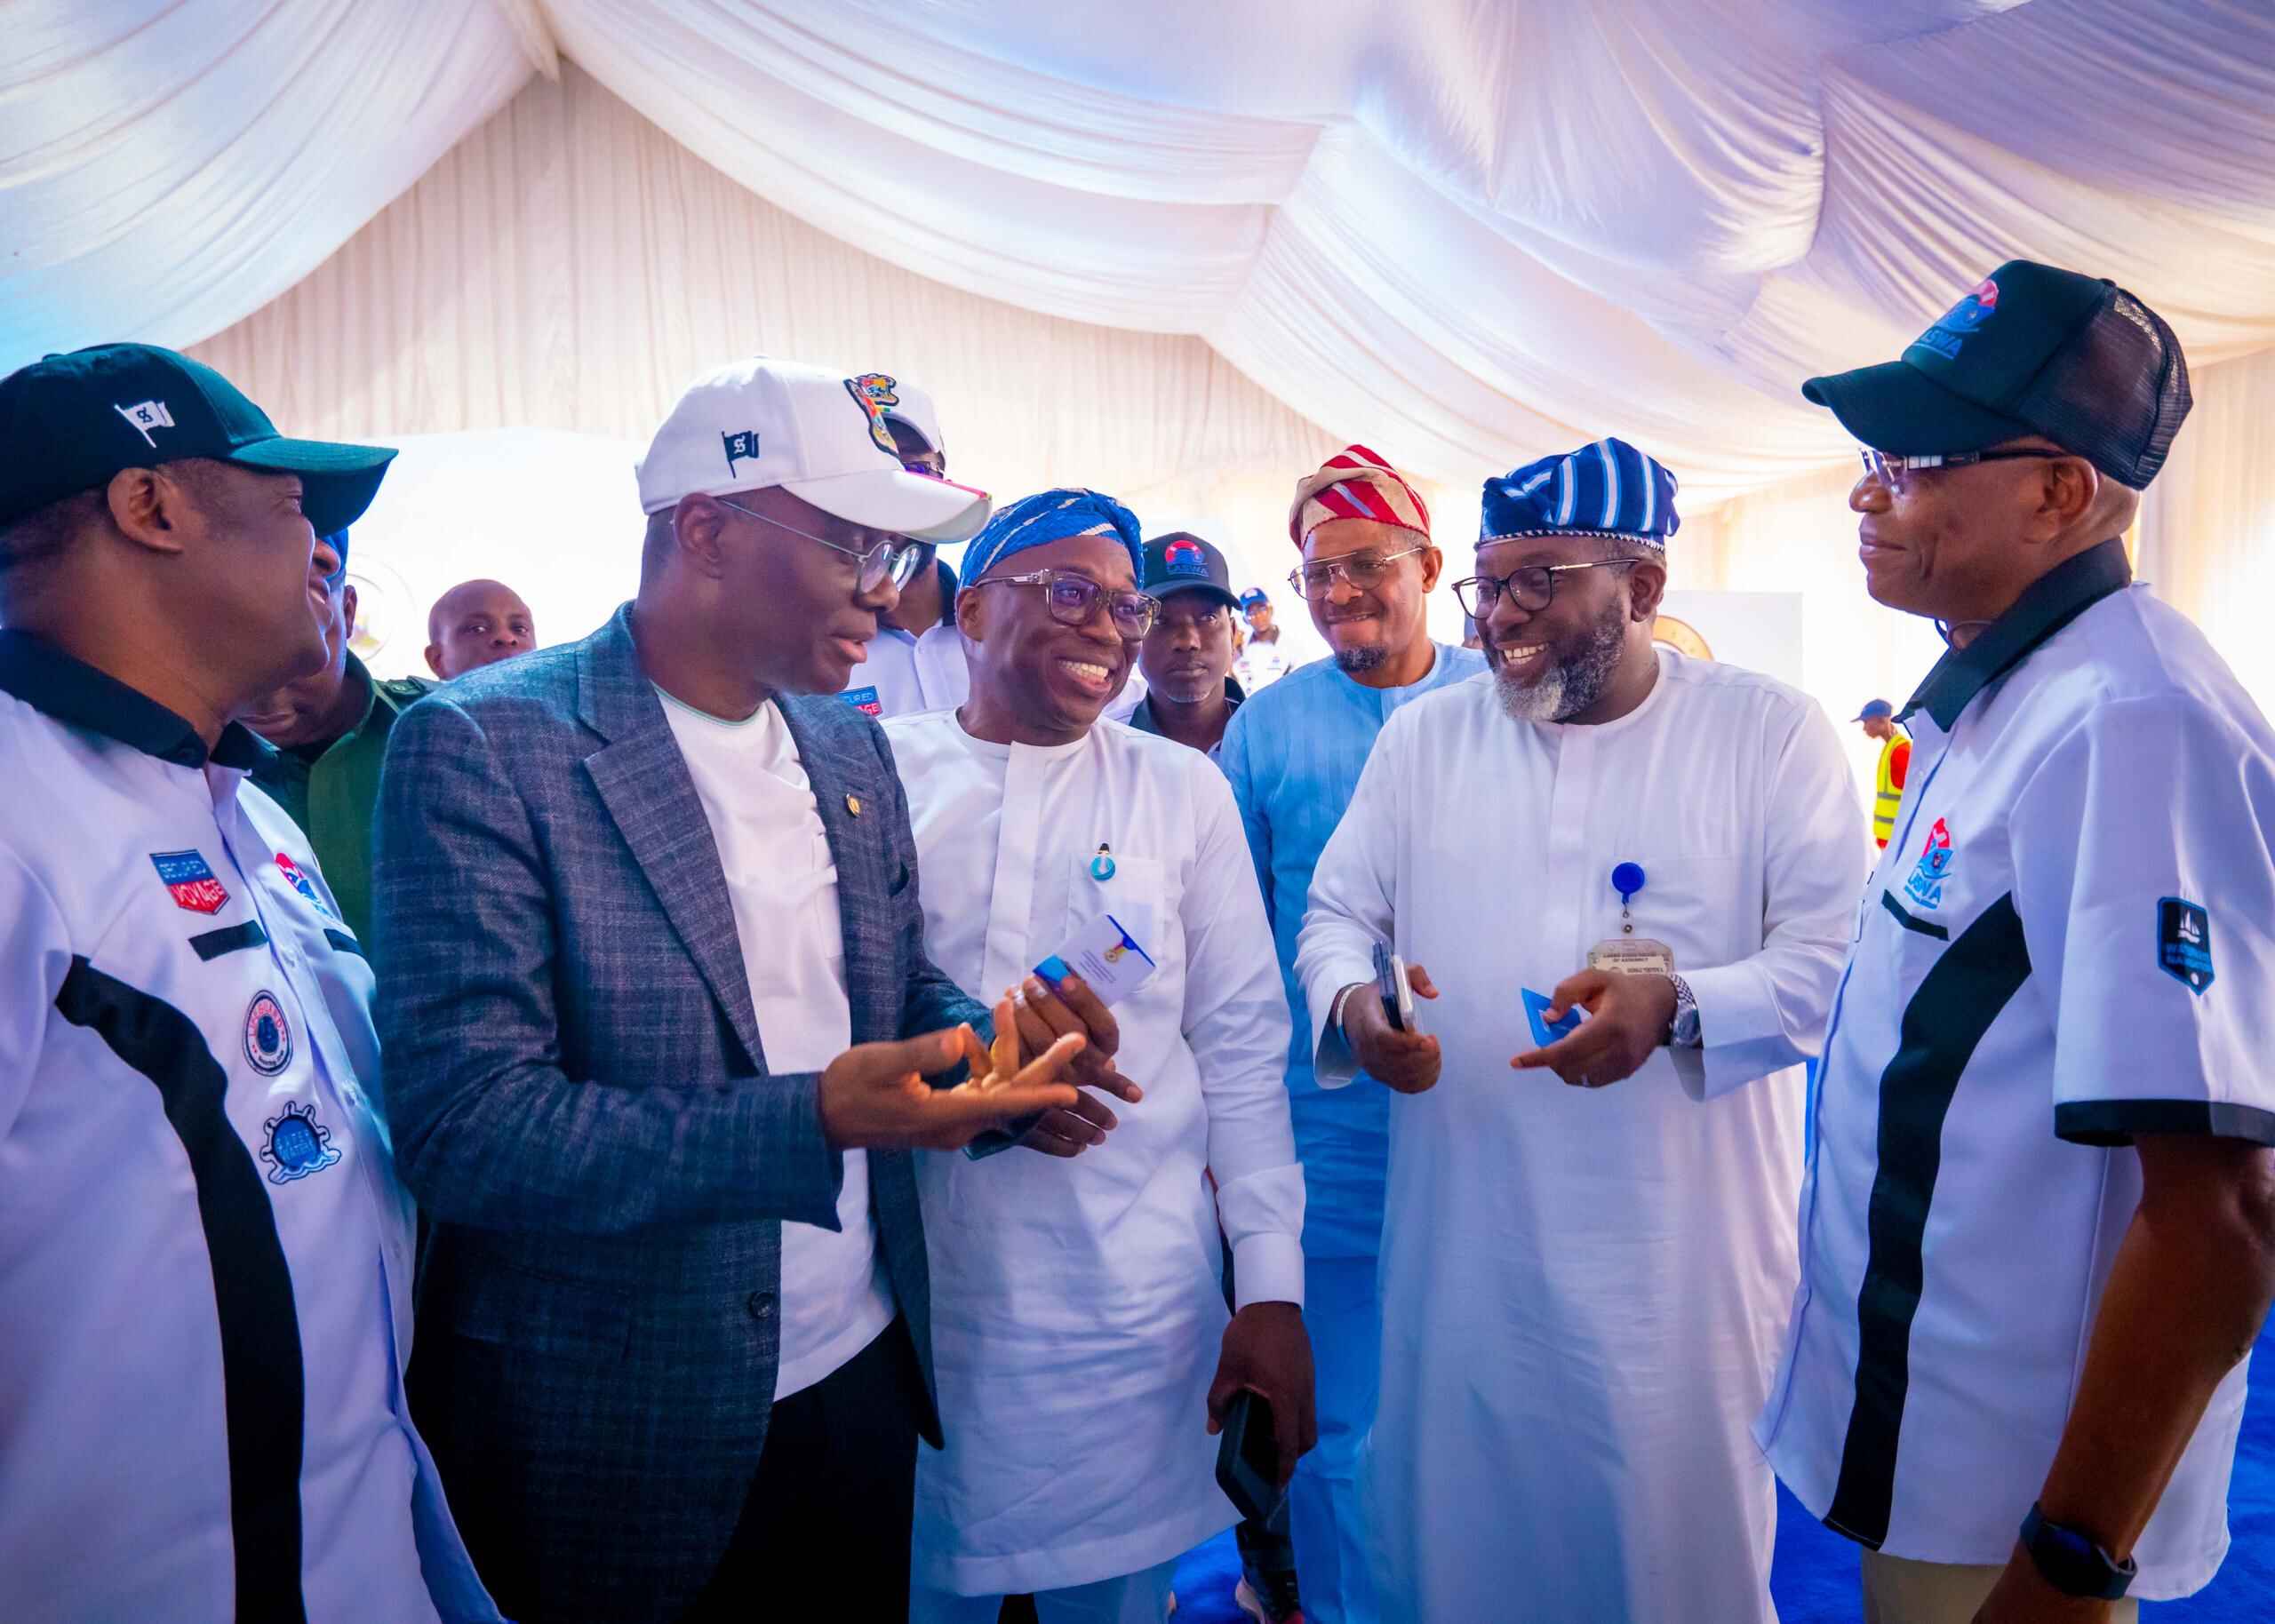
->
xmin=0 ymin=344 xmax=395 ymax=535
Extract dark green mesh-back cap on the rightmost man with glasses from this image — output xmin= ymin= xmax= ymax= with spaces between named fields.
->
xmin=1802 ymin=259 xmax=2191 ymax=491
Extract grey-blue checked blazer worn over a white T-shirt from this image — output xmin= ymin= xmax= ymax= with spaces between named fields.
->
xmin=373 ymin=608 xmax=985 ymax=1624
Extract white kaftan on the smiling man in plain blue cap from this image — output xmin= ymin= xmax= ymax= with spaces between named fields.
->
xmin=885 ymin=712 xmax=1304 ymax=1595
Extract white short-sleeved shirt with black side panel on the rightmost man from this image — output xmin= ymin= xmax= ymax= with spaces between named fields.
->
xmin=1756 ymin=541 xmax=2275 ymax=1601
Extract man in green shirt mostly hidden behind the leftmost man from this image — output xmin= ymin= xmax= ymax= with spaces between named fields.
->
xmin=239 ymin=530 xmax=435 ymax=937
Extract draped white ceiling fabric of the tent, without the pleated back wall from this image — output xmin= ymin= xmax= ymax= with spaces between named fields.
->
xmin=0 ymin=0 xmax=2275 ymax=503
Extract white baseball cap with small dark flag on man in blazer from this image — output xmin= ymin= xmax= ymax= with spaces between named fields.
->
xmin=639 ymin=357 xmax=992 ymax=541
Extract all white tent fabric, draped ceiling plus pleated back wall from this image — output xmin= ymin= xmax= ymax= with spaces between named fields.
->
xmin=0 ymin=0 xmax=2275 ymax=698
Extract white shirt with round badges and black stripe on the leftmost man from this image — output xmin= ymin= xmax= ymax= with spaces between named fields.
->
xmin=0 ymin=633 xmax=499 ymax=1624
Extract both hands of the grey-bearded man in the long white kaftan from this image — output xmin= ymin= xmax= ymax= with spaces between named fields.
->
xmin=1342 ymin=965 xmax=1674 ymax=1094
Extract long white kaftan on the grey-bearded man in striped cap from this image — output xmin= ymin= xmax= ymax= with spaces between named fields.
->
xmin=1297 ymin=649 xmax=1865 ymax=1624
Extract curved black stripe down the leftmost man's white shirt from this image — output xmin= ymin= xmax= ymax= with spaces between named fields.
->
xmin=54 ymin=958 xmax=307 ymax=1624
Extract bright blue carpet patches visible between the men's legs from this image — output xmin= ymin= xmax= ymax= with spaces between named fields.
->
xmin=1177 ymin=1328 xmax=2275 ymax=1624
